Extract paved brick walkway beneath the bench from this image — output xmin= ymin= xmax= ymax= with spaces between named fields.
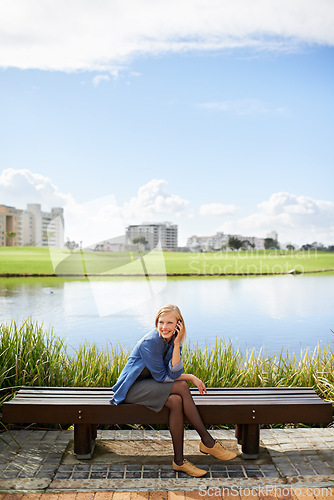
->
xmin=0 ymin=428 xmax=334 ymax=500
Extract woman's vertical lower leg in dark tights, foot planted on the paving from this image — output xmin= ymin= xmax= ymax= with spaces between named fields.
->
xmin=165 ymin=394 xmax=184 ymax=465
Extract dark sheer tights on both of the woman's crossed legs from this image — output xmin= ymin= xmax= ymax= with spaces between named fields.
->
xmin=165 ymin=380 xmax=214 ymax=465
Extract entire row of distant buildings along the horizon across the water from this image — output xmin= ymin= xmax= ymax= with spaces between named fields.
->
xmin=0 ymin=199 xmax=322 ymax=252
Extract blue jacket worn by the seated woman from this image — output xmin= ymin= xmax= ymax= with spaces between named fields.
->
xmin=110 ymin=329 xmax=183 ymax=405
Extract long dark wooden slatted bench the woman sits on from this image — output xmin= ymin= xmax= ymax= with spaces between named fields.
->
xmin=3 ymin=387 xmax=332 ymax=459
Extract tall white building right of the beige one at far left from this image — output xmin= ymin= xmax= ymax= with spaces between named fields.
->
xmin=22 ymin=203 xmax=64 ymax=248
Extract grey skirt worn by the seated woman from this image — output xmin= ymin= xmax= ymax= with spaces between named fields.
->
xmin=123 ymin=377 xmax=174 ymax=412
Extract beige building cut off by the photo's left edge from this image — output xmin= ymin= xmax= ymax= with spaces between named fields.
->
xmin=0 ymin=205 xmax=22 ymax=247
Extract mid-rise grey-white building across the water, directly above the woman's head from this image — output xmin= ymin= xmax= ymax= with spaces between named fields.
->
xmin=126 ymin=222 xmax=178 ymax=250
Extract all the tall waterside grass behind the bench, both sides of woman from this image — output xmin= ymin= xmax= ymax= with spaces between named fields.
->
xmin=0 ymin=321 xmax=334 ymax=408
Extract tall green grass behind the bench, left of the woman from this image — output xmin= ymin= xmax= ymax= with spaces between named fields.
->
xmin=0 ymin=320 xmax=129 ymax=403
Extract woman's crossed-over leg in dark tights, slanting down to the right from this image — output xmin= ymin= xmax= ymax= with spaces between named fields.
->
xmin=171 ymin=380 xmax=215 ymax=448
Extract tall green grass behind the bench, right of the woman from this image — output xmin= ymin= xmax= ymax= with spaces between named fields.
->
xmin=184 ymin=340 xmax=334 ymax=403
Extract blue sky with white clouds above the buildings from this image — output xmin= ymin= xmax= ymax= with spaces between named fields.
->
xmin=0 ymin=0 xmax=334 ymax=244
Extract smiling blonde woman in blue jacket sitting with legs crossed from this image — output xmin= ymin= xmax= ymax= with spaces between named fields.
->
xmin=110 ymin=304 xmax=236 ymax=477
